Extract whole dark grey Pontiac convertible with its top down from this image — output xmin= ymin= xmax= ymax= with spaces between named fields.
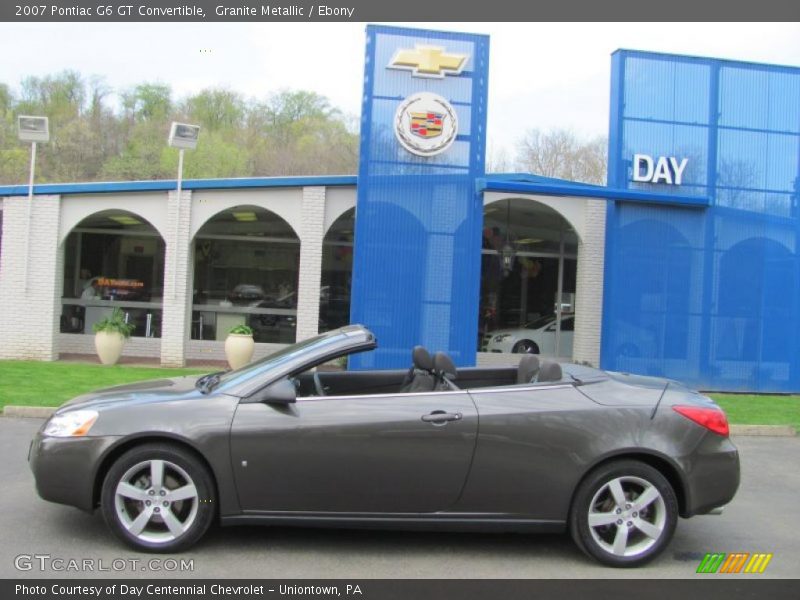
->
xmin=29 ymin=325 xmax=739 ymax=567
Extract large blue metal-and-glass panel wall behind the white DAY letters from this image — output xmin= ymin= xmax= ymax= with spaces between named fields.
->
xmin=601 ymin=51 xmax=800 ymax=392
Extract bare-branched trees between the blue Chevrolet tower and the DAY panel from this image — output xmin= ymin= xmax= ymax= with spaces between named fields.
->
xmin=517 ymin=129 xmax=607 ymax=185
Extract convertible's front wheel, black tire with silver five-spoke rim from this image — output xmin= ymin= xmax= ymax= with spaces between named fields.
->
xmin=100 ymin=443 xmax=216 ymax=552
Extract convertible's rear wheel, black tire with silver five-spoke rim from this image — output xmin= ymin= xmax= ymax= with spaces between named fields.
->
xmin=569 ymin=460 xmax=678 ymax=567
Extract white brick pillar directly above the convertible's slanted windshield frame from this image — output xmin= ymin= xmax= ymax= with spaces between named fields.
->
xmin=297 ymin=187 xmax=325 ymax=342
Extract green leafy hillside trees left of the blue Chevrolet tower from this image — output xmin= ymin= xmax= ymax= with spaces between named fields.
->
xmin=0 ymin=71 xmax=358 ymax=184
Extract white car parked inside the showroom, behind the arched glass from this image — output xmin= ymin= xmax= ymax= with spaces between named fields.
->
xmin=481 ymin=314 xmax=575 ymax=356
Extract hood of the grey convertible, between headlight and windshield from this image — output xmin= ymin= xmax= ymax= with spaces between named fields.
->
xmin=56 ymin=375 xmax=203 ymax=413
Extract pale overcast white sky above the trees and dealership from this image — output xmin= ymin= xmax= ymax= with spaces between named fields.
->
xmin=0 ymin=23 xmax=800 ymax=163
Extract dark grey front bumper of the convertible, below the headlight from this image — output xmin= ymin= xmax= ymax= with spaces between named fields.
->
xmin=28 ymin=431 xmax=119 ymax=512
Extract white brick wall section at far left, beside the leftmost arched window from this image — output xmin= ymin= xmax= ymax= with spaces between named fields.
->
xmin=0 ymin=196 xmax=63 ymax=360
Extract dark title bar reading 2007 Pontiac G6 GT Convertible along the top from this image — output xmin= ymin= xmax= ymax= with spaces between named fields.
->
xmin=0 ymin=0 xmax=798 ymax=23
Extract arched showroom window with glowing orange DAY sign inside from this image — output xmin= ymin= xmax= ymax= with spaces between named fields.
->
xmin=61 ymin=210 xmax=165 ymax=337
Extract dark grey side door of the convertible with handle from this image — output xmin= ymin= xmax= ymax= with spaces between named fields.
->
xmin=231 ymin=391 xmax=478 ymax=513
